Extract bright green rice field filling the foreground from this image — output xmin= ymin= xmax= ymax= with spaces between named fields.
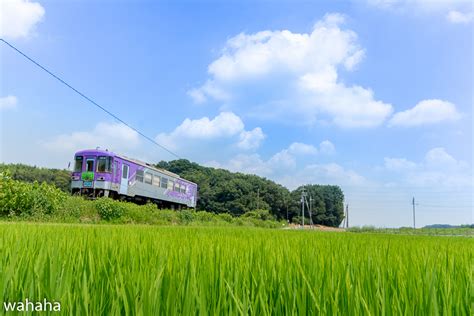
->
xmin=0 ymin=223 xmax=474 ymax=315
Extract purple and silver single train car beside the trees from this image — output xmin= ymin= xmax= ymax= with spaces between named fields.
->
xmin=71 ymin=149 xmax=197 ymax=208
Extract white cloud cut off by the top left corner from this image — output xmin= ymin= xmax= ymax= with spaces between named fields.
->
xmin=0 ymin=0 xmax=44 ymax=39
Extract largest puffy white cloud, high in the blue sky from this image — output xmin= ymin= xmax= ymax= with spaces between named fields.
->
xmin=188 ymin=14 xmax=392 ymax=127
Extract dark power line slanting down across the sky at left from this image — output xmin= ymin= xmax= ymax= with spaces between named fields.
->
xmin=0 ymin=38 xmax=180 ymax=159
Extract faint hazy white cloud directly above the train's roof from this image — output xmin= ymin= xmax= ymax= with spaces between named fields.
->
xmin=42 ymin=122 xmax=140 ymax=153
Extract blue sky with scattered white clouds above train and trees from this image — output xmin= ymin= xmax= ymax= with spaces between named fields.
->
xmin=0 ymin=0 xmax=473 ymax=227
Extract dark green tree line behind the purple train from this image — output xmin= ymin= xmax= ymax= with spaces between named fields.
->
xmin=0 ymin=159 xmax=344 ymax=226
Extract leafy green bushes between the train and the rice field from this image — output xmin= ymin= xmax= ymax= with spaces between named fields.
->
xmin=0 ymin=173 xmax=286 ymax=228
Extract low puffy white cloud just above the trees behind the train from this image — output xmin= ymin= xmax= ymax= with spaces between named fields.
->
xmin=156 ymin=112 xmax=265 ymax=150
